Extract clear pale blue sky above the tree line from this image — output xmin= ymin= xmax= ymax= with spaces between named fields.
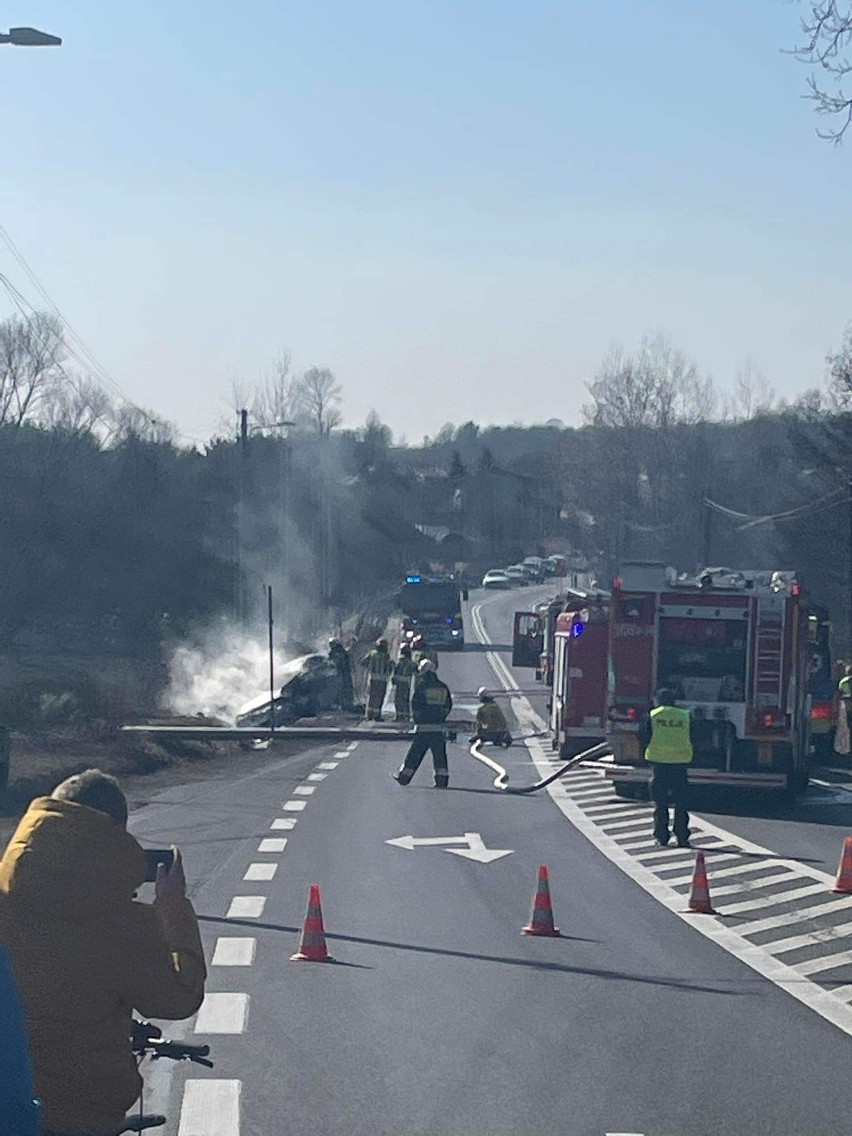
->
xmin=0 ymin=0 xmax=852 ymax=441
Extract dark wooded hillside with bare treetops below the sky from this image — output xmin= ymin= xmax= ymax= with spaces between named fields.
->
xmin=0 ymin=316 xmax=852 ymax=727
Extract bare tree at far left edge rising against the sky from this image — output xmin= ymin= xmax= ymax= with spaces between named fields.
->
xmin=0 ymin=311 xmax=65 ymax=426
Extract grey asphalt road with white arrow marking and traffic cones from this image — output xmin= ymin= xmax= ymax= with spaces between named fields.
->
xmin=132 ymin=593 xmax=852 ymax=1136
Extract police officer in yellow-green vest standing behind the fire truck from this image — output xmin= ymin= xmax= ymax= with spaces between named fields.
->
xmin=640 ymin=687 xmax=693 ymax=849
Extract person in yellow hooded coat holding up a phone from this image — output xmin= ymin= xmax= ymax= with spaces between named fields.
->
xmin=0 ymin=769 xmax=207 ymax=1136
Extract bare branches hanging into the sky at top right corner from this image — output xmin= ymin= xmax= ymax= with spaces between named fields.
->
xmin=793 ymin=0 xmax=852 ymax=144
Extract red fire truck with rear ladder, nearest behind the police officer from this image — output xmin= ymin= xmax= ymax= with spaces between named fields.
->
xmin=607 ymin=562 xmax=811 ymax=796
